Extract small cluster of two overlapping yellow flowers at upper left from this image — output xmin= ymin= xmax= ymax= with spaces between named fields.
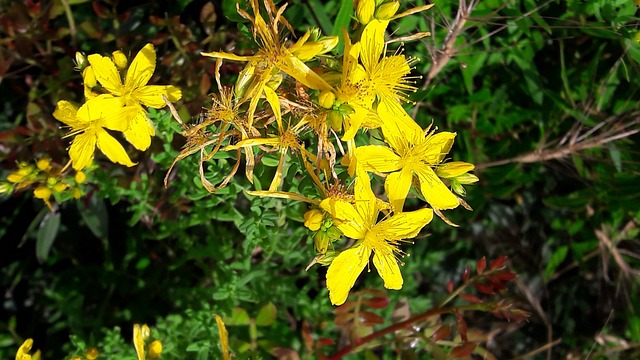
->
xmin=53 ymin=44 xmax=182 ymax=170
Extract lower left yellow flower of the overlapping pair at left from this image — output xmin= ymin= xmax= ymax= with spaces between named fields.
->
xmin=53 ymin=95 xmax=137 ymax=170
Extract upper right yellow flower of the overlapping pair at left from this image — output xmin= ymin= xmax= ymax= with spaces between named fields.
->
xmin=85 ymin=44 xmax=182 ymax=150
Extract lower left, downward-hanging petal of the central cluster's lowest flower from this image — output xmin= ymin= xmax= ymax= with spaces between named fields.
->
xmin=327 ymin=246 xmax=371 ymax=305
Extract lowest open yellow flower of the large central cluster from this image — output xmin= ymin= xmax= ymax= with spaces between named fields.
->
xmin=320 ymin=168 xmax=433 ymax=305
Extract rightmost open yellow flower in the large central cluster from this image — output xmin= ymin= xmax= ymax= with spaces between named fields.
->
xmin=355 ymin=123 xmax=473 ymax=212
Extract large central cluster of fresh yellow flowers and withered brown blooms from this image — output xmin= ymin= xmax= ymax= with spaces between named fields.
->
xmin=168 ymin=0 xmax=478 ymax=305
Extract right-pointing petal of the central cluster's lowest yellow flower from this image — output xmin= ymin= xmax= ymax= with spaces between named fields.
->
xmin=372 ymin=208 xmax=433 ymax=240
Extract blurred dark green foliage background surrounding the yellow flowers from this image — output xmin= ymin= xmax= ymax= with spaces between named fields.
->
xmin=0 ymin=0 xmax=640 ymax=359
